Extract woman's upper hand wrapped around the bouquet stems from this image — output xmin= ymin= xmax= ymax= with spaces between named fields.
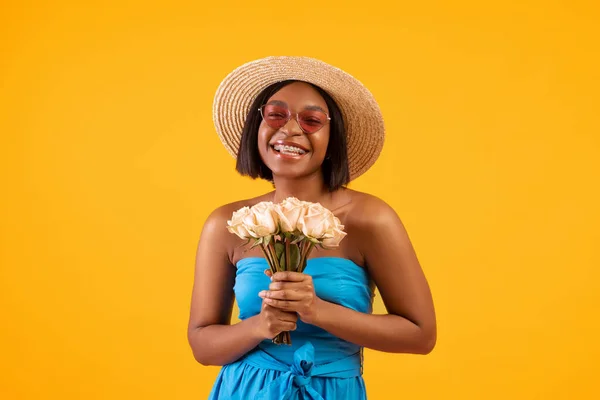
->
xmin=258 ymin=270 xmax=322 ymax=324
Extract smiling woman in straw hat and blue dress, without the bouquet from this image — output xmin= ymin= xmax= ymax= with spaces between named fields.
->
xmin=188 ymin=57 xmax=436 ymax=400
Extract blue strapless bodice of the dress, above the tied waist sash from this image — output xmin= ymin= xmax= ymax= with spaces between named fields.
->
xmin=234 ymin=257 xmax=374 ymax=364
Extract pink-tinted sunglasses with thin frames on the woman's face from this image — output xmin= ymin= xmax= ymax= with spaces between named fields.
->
xmin=258 ymin=104 xmax=331 ymax=133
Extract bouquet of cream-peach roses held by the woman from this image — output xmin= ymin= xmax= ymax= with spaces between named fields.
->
xmin=227 ymin=197 xmax=346 ymax=344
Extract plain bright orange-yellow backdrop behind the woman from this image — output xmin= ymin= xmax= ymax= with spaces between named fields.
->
xmin=0 ymin=0 xmax=600 ymax=400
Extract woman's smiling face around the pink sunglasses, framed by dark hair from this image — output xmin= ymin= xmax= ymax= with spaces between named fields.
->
xmin=258 ymin=82 xmax=330 ymax=178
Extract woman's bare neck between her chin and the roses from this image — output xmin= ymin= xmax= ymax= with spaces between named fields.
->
xmin=272 ymin=174 xmax=331 ymax=205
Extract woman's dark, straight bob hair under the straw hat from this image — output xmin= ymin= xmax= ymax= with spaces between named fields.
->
xmin=235 ymin=80 xmax=350 ymax=192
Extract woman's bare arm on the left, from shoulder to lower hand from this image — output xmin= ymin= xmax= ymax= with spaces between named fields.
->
xmin=188 ymin=208 xmax=297 ymax=365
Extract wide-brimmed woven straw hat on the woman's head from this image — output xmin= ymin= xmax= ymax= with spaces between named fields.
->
xmin=213 ymin=56 xmax=384 ymax=179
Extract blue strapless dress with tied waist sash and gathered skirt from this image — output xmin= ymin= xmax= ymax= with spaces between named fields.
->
xmin=209 ymin=257 xmax=373 ymax=400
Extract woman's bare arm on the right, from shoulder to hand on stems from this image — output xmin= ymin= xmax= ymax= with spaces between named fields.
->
xmin=265 ymin=199 xmax=437 ymax=354
